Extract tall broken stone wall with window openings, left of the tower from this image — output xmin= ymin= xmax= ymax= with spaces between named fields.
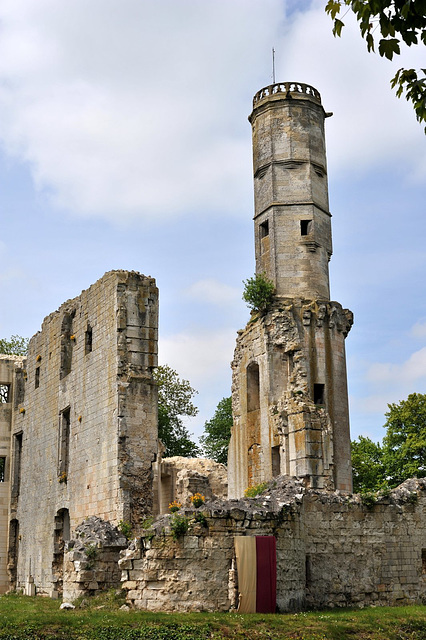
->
xmin=11 ymin=271 xmax=158 ymax=593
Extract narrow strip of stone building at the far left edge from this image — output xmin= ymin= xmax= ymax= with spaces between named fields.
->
xmin=0 ymin=355 xmax=24 ymax=593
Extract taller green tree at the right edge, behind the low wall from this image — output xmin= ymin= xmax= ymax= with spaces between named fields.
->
xmin=383 ymin=393 xmax=426 ymax=487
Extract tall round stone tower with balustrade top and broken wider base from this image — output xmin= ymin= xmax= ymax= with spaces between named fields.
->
xmin=228 ymin=82 xmax=353 ymax=497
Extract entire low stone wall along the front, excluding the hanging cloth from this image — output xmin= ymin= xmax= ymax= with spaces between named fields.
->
xmin=119 ymin=478 xmax=426 ymax=611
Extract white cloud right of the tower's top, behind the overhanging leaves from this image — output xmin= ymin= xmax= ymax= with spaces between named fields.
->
xmin=278 ymin=0 xmax=426 ymax=182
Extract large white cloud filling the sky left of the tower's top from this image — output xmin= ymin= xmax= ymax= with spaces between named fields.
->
xmin=0 ymin=0 xmax=283 ymax=220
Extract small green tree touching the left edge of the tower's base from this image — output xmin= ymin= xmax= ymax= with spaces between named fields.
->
xmin=200 ymin=397 xmax=232 ymax=464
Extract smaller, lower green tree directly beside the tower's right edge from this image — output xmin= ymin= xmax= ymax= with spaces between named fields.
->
xmin=351 ymin=436 xmax=386 ymax=493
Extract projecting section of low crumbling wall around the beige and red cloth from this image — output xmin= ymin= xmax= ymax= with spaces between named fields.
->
xmin=119 ymin=478 xmax=305 ymax=611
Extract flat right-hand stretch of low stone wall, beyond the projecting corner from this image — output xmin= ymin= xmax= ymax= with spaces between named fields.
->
xmin=304 ymin=480 xmax=426 ymax=607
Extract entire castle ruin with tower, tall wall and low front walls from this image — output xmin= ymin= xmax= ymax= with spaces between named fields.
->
xmin=0 ymin=83 xmax=426 ymax=612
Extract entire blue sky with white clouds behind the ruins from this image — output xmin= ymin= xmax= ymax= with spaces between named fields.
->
xmin=0 ymin=0 xmax=426 ymax=448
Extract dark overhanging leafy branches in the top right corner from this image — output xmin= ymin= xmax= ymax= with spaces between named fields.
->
xmin=325 ymin=0 xmax=426 ymax=133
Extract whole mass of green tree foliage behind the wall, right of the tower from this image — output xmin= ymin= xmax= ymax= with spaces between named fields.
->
xmin=351 ymin=393 xmax=426 ymax=492
